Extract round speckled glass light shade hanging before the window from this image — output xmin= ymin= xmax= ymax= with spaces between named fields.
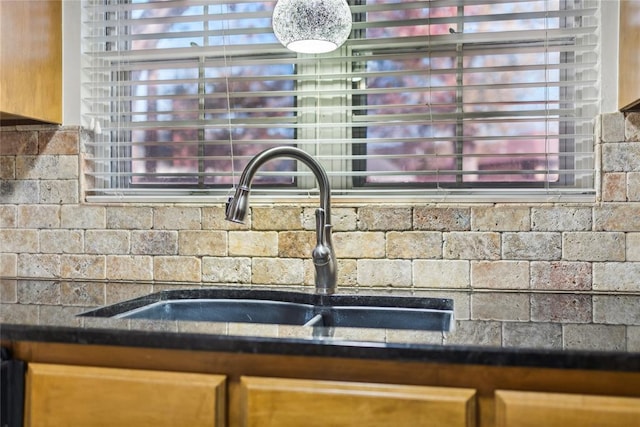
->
xmin=273 ymin=0 xmax=351 ymax=53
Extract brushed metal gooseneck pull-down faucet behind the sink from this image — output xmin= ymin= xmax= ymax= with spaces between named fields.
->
xmin=226 ymin=146 xmax=337 ymax=295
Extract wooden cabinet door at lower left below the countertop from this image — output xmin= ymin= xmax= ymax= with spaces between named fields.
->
xmin=25 ymin=363 xmax=225 ymax=427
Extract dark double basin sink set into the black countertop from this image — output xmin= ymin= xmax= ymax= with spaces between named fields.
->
xmin=81 ymin=288 xmax=453 ymax=331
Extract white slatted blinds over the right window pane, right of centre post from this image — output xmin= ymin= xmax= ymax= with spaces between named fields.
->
xmin=351 ymin=0 xmax=598 ymax=188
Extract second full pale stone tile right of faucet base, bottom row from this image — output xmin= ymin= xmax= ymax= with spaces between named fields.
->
xmin=413 ymin=260 xmax=471 ymax=289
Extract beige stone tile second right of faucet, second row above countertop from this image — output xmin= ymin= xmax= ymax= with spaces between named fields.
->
xmin=386 ymin=231 xmax=442 ymax=259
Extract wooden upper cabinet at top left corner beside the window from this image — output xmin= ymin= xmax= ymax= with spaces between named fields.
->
xmin=0 ymin=0 xmax=62 ymax=125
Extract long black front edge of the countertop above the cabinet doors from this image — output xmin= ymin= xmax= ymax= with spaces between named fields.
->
xmin=0 ymin=323 xmax=640 ymax=372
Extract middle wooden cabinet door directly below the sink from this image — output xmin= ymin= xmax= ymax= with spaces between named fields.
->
xmin=240 ymin=377 xmax=476 ymax=427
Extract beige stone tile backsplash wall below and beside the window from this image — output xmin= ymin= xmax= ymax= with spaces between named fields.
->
xmin=0 ymin=113 xmax=640 ymax=341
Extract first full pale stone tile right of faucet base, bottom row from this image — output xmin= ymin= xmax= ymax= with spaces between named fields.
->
xmin=358 ymin=259 xmax=411 ymax=287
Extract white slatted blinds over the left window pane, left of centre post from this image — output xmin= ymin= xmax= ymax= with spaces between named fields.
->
xmin=86 ymin=0 xmax=297 ymax=194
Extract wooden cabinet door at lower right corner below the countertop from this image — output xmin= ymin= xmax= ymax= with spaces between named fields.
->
xmin=496 ymin=390 xmax=640 ymax=427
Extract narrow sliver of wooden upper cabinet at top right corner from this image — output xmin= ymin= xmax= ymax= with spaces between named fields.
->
xmin=618 ymin=0 xmax=640 ymax=111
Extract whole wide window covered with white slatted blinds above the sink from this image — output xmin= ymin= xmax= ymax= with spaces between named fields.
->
xmin=84 ymin=0 xmax=599 ymax=200
